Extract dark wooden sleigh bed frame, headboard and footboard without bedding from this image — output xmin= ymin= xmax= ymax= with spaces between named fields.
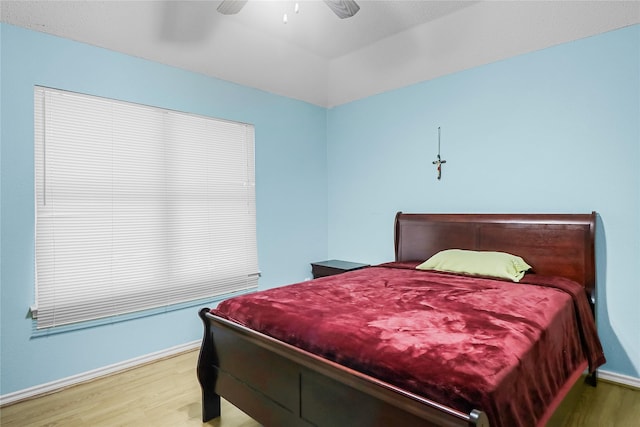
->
xmin=197 ymin=213 xmax=604 ymax=427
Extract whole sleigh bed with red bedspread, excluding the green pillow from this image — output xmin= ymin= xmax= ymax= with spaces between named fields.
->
xmin=197 ymin=213 xmax=605 ymax=426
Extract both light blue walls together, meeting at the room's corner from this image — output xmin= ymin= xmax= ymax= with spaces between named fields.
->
xmin=0 ymin=24 xmax=640 ymax=395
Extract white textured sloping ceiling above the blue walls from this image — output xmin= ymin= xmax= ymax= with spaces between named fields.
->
xmin=0 ymin=0 xmax=640 ymax=107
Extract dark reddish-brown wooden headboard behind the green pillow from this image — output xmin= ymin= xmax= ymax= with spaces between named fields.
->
xmin=395 ymin=212 xmax=596 ymax=297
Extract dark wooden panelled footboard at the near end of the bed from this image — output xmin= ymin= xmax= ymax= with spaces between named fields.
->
xmin=197 ymin=308 xmax=489 ymax=427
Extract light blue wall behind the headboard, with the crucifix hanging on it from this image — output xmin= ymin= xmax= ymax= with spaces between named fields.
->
xmin=327 ymin=25 xmax=640 ymax=378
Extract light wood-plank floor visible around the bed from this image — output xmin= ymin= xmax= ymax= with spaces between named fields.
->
xmin=0 ymin=351 xmax=640 ymax=427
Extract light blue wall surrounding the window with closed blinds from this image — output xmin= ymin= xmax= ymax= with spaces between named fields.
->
xmin=0 ymin=24 xmax=327 ymax=395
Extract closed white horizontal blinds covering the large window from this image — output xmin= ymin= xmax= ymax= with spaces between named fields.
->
xmin=34 ymin=87 xmax=258 ymax=329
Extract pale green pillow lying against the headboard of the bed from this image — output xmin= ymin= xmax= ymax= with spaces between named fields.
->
xmin=416 ymin=249 xmax=531 ymax=282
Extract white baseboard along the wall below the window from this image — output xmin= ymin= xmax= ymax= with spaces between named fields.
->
xmin=0 ymin=340 xmax=201 ymax=407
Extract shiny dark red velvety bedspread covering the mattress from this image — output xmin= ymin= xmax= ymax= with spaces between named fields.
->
xmin=212 ymin=264 xmax=604 ymax=427
